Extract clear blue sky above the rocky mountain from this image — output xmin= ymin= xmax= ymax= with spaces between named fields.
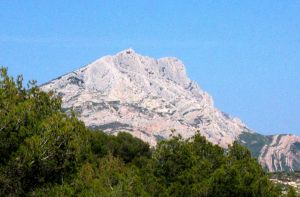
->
xmin=0 ymin=0 xmax=300 ymax=135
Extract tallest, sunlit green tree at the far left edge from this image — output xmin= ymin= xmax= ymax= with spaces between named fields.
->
xmin=0 ymin=68 xmax=89 ymax=196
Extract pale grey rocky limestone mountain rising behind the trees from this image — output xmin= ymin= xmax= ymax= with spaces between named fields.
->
xmin=41 ymin=49 xmax=300 ymax=171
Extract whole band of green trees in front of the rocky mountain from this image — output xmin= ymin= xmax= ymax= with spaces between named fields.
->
xmin=0 ymin=68 xmax=296 ymax=197
